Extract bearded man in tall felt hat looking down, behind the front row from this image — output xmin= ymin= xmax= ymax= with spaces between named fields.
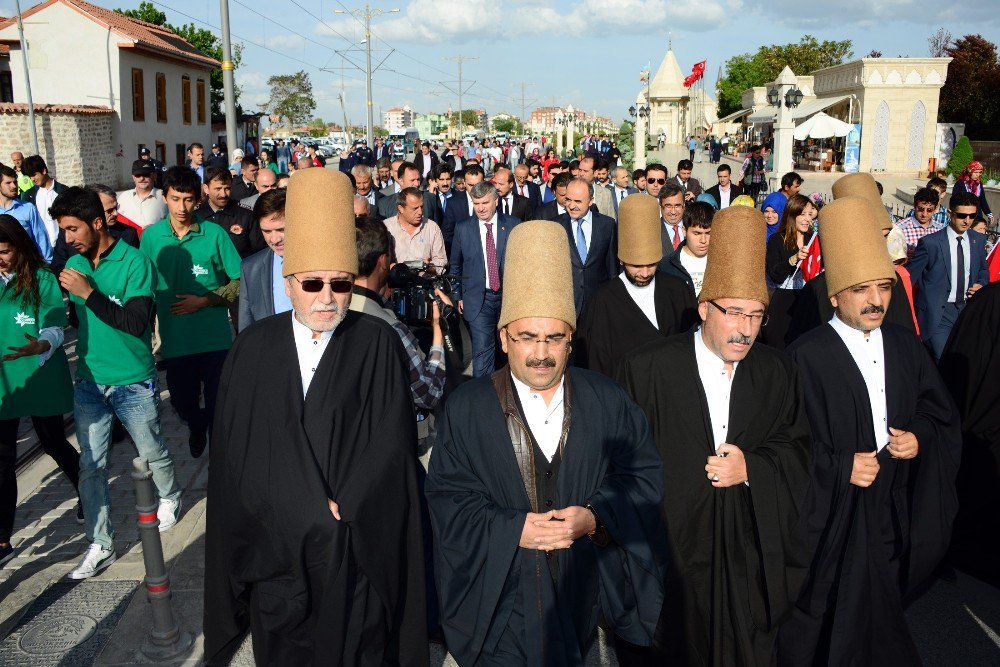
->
xmin=574 ymin=193 xmax=697 ymax=378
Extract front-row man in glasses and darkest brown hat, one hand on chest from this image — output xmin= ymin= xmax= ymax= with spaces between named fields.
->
xmin=618 ymin=206 xmax=812 ymax=665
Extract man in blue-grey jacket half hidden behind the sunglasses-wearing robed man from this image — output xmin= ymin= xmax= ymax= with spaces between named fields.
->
xmin=237 ymin=189 xmax=292 ymax=331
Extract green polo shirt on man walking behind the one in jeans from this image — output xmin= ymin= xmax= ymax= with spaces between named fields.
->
xmin=139 ymin=218 xmax=240 ymax=359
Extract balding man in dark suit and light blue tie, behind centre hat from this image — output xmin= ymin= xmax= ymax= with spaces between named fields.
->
xmin=557 ymin=178 xmax=618 ymax=316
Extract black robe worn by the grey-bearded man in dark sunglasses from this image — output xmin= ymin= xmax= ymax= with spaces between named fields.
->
xmin=204 ymin=311 xmax=428 ymax=667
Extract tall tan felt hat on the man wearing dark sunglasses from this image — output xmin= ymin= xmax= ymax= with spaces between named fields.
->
xmin=282 ymin=169 xmax=358 ymax=278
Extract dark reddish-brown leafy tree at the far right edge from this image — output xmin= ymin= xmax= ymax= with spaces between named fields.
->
xmin=938 ymin=35 xmax=1000 ymax=140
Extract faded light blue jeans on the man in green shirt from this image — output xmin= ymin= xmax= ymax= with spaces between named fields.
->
xmin=73 ymin=376 xmax=182 ymax=549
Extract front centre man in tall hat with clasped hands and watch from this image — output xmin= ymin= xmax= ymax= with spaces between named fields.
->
xmin=426 ymin=220 xmax=666 ymax=667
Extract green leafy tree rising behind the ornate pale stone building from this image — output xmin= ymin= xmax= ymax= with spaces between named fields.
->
xmin=715 ymin=35 xmax=854 ymax=116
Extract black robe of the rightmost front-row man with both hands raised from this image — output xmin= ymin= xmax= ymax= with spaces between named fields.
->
xmin=779 ymin=324 xmax=960 ymax=667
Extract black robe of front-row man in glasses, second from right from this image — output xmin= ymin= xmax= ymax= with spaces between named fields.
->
xmin=619 ymin=332 xmax=811 ymax=666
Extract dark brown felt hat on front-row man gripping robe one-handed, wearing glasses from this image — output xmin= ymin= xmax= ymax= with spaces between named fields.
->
xmin=698 ymin=206 xmax=769 ymax=306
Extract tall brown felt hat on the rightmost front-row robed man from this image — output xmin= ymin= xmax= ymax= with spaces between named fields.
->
xmin=816 ymin=197 xmax=896 ymax=296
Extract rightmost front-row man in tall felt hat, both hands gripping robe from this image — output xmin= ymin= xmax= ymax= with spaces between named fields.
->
xmin=779 ymin=195 xmax=961 ymax=665
